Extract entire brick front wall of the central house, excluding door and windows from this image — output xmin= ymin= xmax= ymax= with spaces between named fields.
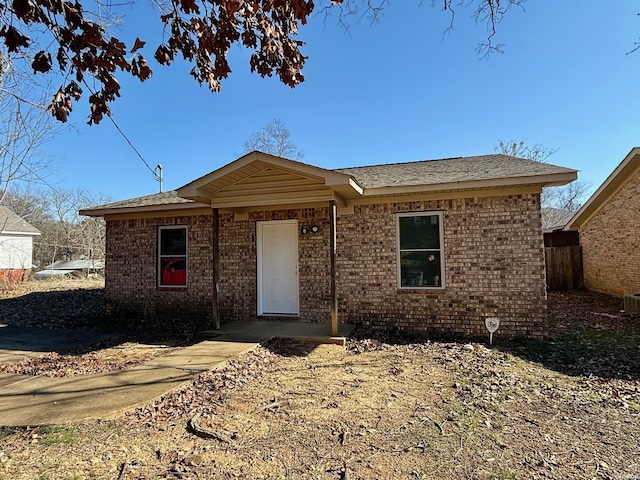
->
xmin=106 ymin=194 xmax=546 ymax=337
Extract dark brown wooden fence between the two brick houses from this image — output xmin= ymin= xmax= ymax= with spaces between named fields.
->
xmin=544 ymin=246 xmax=584 ymax=290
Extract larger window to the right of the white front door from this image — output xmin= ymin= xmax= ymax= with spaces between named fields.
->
xmin=396 ymin=212 xmax=444 ymax=288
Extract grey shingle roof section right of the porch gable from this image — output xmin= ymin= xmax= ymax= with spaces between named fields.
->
xmin=336 ymin=154 xmax=574 ymax=188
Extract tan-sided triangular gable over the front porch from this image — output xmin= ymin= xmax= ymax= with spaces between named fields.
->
xmin=178 ymin=152 xmax=363 ymax=208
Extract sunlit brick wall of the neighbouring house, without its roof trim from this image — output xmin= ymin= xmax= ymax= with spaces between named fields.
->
xmin=580 ymin=171 xmax=640 ymax=297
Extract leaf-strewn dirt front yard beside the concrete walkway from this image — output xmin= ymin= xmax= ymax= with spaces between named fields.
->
xmin=0 ymin=285 xmax=640 ymax=480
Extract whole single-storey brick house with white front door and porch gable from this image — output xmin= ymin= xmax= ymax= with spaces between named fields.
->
xmin=81 ymin=152 xmax=576 ymax=337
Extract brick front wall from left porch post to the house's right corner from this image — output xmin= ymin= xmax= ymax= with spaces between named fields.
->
xmin=220 ymin=194 xmax=546 ymax=337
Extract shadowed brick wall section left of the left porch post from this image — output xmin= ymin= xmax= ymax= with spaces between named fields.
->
xmin=105 ymin=215 xmax=213 ymax=331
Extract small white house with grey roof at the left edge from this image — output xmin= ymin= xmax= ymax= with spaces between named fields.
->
xmin=0 ymin=206 xmax=40 ymax=281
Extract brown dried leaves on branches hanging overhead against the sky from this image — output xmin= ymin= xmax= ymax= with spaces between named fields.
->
xmin=0 ymin=0 xmax=314 ymax=124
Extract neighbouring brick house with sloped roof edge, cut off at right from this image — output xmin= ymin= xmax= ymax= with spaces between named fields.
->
xmin=565 ymin=147 xmax=640 ymax=297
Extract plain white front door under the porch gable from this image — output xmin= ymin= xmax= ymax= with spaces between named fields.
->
xmin=257 ymin=220 xmax=299 ymax=315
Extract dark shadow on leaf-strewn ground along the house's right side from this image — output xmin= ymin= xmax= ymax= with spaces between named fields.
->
xmin=350 ymin=291 xmax=640 ymax=380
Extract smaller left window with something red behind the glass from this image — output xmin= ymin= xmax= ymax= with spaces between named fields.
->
xmin=158 ymin=227 xmax=187 ymax=287
